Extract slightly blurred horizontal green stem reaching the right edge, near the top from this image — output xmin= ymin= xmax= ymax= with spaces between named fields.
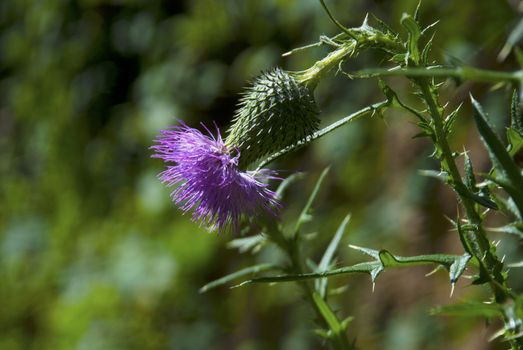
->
xmin=356 ymin=66 xmax=523 ymax=86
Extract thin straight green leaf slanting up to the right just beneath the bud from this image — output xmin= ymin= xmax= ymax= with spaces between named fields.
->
xmin=256 ymin=101 xmax=390 ymax=170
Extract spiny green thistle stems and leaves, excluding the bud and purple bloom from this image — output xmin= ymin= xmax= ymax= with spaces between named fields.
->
xmin=194 ymin=1 xmax=523 ymax=349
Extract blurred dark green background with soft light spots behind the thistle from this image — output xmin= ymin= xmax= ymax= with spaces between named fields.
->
xmin=0 ymin=0 xmax=523 ymax=350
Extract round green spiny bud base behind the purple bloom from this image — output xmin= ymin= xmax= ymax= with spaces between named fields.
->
xmin=226 ymin=68 xmax=319 ymax=168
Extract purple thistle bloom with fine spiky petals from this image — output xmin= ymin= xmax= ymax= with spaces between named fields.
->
xmin=151 ymin=123 xmax=279 ymax=232
